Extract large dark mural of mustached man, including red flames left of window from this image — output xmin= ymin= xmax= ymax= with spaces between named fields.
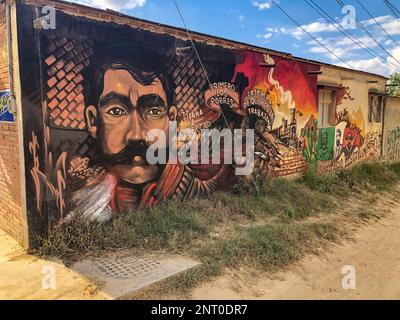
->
xmin=18 ymin=4 xmax=318 ymax=238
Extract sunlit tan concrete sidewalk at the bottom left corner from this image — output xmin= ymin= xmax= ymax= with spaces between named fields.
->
xmin=0 ymin=229 xmax=110 ymax=300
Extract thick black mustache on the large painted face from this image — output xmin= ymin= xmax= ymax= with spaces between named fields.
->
xmin=101 ymin=140 xmax=149 ymax=166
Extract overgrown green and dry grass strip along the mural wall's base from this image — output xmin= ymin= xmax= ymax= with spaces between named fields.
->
xmin=34 ymin=163 xmax=400 ymax=293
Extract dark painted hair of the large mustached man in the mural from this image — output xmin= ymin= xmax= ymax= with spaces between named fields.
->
xmin=84 ymin=44 xmax=174 ymax=108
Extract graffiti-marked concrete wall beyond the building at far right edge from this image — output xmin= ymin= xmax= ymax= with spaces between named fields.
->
xmin=383 ymin=97 xmax=400 ymax=162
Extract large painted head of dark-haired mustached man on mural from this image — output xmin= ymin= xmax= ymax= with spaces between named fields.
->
xmin=85 ymin=42 xmax=177 ymax=185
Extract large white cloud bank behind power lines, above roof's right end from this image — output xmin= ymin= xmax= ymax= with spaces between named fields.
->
xmin=257 ymin=15 xmax=400 ymax=76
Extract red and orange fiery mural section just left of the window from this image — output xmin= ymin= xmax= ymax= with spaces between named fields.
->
xmin=234 ymin=52 xmax=319 ymax=176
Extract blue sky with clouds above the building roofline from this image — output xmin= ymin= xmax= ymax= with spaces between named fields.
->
xmin=69 ymin=0 xmax=400 ymax=76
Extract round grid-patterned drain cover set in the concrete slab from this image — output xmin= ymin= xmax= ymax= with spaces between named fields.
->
xmin=93 ymin=257 xmax=160 ymax=279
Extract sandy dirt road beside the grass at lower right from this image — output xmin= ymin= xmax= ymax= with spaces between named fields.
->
xmin=192 ymin=191 xmax=400 ymax=299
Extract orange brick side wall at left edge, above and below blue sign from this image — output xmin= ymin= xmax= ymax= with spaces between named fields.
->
xmin=0 ymin=5 xmax=24 ymax=242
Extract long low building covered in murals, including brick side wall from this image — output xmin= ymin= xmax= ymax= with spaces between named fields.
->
xmin=0 ymin=0 xmax=400 ymax=246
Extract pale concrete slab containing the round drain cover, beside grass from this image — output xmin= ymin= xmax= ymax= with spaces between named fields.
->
xmin=72 ymin=253 xmax=199 ymax=299
